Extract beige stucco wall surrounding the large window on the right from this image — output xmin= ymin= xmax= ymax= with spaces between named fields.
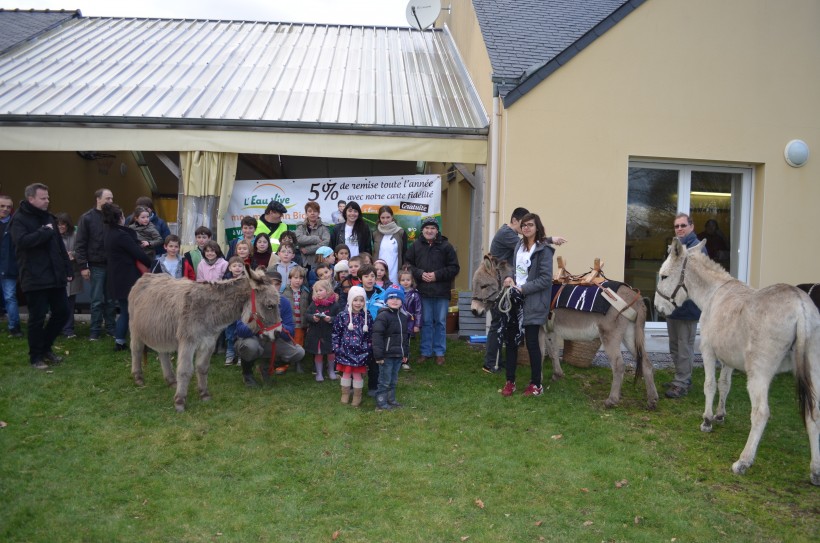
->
xmin=494 ymin=0 xmax=820 ymax=286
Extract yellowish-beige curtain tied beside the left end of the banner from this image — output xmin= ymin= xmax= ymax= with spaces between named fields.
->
xmin=179 ymin=151 xmax=239 ymax=250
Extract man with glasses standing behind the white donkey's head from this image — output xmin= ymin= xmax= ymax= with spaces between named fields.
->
xmin=664 ymin=213 xmax=706 ymax=399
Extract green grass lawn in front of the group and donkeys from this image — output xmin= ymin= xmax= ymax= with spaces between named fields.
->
xmin=0 ymin=327 xmax=820 ymax=543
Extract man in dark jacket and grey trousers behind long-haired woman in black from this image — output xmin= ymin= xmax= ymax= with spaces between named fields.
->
xmin=74 ymin=189 xmax=117 ymax=341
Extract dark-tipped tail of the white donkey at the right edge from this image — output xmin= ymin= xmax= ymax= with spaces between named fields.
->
xmin=794 ymin=300 xmax=820 ymax=423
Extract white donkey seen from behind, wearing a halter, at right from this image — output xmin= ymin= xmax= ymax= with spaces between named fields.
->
xmin=655 ymin=239 xmax=820 ymax=485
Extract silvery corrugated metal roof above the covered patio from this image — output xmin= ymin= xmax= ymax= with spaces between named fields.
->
xmin=0 ymin=18 xmax=488 ymax=135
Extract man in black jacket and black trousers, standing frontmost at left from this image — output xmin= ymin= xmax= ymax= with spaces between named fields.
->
xmin=10 ymin=183 xmax=74 ymax=370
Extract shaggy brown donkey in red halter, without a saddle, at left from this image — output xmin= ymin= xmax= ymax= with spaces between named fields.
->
xmin=128 ymin=271 xmax=282 ymax=412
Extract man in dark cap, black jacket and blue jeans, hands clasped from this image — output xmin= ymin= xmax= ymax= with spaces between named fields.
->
xmin=405 ymin=217 xmax=461 ymax=366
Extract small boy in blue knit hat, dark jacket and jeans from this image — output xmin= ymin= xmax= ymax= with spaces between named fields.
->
xmin=372 ymin=285 xmax=410 ymax=411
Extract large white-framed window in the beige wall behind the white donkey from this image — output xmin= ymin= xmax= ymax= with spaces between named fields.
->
xmin=624 ymin=161 xmax=752 ymax=320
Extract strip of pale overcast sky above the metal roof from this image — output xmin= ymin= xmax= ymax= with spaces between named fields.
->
xmin=0 ymin=0 xmax=416 ymax=26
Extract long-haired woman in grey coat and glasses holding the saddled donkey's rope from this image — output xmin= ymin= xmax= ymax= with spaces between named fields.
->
xmin=501 ymin=213 xmax=555 ymax=396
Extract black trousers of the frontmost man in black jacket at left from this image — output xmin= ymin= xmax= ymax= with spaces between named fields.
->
xmin=26 ymin=287 xmax=68 ymax=364
